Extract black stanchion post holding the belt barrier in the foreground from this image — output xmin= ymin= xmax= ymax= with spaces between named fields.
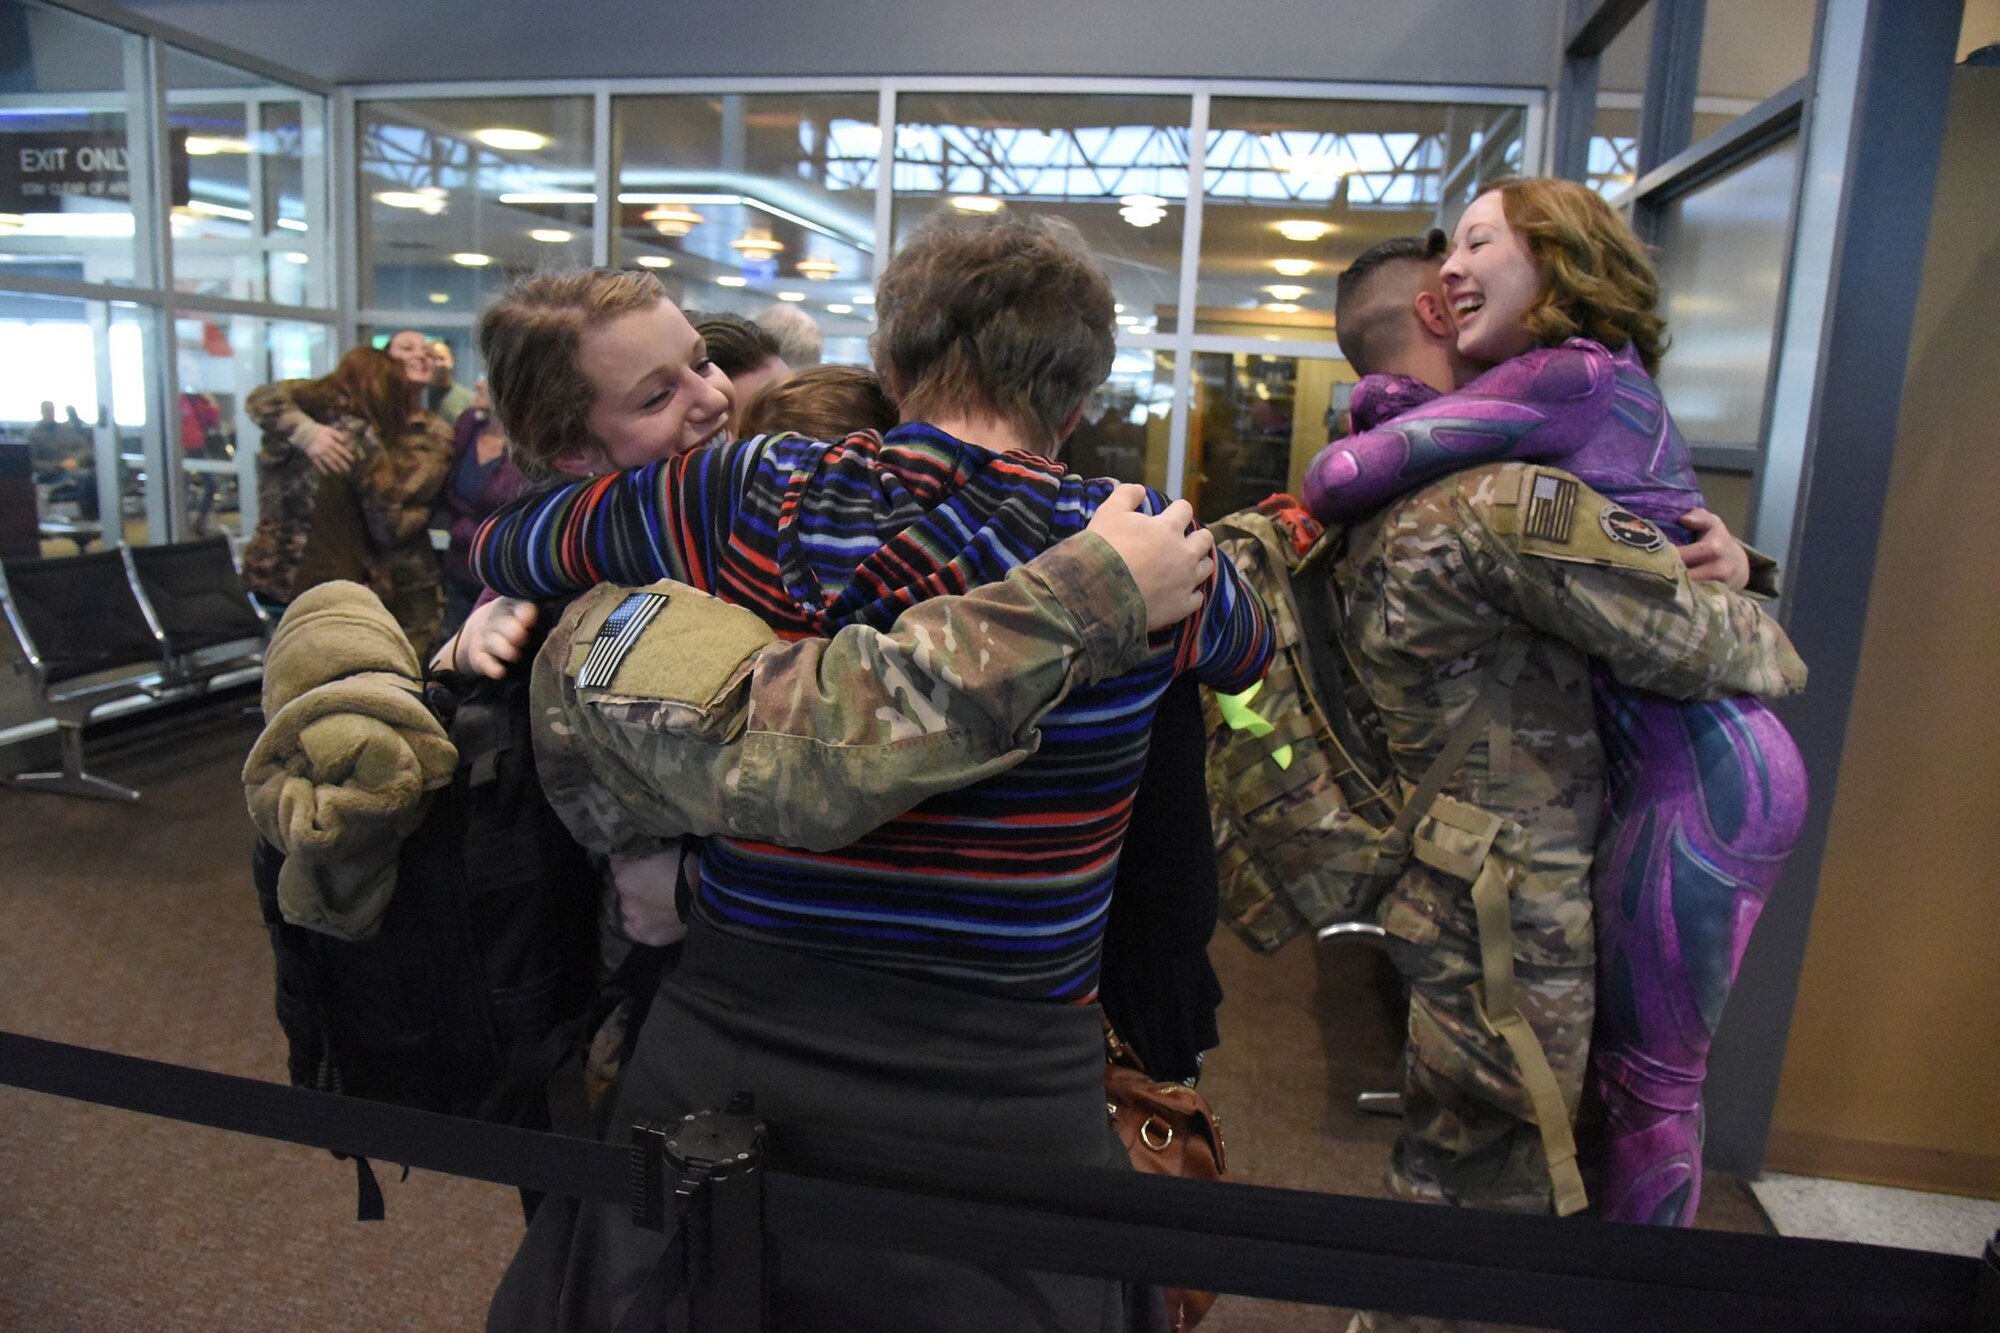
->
xmin=632 ymin=1093 xmax=768 ymax=1333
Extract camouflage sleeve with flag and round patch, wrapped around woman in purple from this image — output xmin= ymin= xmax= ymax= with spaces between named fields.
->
xmin=1456 ymin=466 xmax=1806 ymax=701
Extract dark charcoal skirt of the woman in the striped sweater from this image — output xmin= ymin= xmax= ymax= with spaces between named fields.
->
xmin=488 ymin=921 xmax=1152 ymax=1333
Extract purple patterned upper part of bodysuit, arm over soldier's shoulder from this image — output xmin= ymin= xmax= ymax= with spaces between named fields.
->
xmin=1304 ymin=338 xmax=1702 ymax=536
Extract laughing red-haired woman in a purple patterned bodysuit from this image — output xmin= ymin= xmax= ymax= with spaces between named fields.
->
xmin=1304 ymin=180 xmax=1806 ymax=1225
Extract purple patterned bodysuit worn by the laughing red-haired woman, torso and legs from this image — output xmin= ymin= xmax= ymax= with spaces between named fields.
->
xmin=1306 ymin=338 xmax=1806 ymax=1225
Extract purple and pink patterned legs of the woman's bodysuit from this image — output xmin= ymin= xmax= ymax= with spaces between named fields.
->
xmin=1590 ymin=669 xmax=1806 ymax=1227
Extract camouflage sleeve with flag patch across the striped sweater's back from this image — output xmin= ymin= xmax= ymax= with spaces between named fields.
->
xmin=532 ymin=532 xmax=1150 ymax=855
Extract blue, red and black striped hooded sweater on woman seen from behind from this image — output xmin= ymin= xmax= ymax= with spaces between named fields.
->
xmin=472 ymin=426 xmax=1270 ymax=1001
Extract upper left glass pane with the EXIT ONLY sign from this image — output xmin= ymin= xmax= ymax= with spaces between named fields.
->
xmin=0 ymin=2 xmax=144 ymax=284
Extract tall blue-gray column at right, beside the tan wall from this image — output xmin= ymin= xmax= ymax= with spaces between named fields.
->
xmin=1708 ymin=0 xmax=1962 ymax=1175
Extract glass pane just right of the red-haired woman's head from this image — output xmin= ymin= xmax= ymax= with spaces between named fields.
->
xmin=1658 ymin=134 xmax=1798 ymax=444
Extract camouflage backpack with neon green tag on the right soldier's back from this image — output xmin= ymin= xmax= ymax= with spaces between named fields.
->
xmin=1202 ymin=494 xmax=1526 ymax=953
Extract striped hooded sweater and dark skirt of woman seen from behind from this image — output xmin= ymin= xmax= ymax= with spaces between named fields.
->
xmin=472 ymin=424 xmax=1270 ymax=1329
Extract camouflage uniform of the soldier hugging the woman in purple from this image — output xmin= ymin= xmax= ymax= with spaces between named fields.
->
xmin=1336 ymin=462 xmax=1806 ymax=1329
